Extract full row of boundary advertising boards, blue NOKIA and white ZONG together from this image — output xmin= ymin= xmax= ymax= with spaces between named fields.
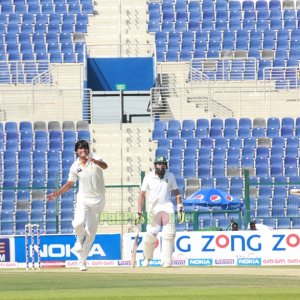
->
xmin=0 ymin=230 xmax=300 ymax=268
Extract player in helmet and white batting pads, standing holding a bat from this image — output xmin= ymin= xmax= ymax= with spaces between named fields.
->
xmin=138 ymin=156 xmax=184 ymax=268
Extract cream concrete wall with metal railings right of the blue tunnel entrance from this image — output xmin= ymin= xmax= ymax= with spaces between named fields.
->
xmin=150 ymin=59 xmax=300 ymax=120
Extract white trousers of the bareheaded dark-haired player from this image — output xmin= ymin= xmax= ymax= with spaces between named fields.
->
xmin=72 ymin=196 xmax=105 ymax=262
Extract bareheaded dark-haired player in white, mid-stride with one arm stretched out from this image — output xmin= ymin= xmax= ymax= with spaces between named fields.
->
xmin=47 ymin=140 xmax=107 ymax=271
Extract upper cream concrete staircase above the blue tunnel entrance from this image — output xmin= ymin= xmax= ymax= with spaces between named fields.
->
xmin=86 ymin=0 xmax=154 ymax=57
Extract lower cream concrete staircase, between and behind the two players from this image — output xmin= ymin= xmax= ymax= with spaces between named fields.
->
xmin=91 ymin=124 xmax=154 ymax=233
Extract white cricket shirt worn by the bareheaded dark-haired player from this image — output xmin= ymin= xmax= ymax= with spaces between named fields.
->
xmin=68 ymin=156 xmax=105 ymax=198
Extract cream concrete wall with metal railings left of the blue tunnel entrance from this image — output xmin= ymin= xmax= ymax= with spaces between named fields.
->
xmin=0 ymin=61 xmax=85 ymax=121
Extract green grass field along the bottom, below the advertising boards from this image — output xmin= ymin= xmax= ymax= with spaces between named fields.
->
xmin=0 ymin=266 xmax=300 ymax=300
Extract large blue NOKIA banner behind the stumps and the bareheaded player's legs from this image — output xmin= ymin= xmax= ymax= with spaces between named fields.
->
xmin=15 ymin=234 xmax=121 ymax=263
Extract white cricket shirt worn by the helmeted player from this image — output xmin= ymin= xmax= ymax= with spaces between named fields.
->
xmin=141 ymin=170 xmax=178 ymax=209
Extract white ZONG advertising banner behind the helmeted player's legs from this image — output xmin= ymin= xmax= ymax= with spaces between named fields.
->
xmin=123 ymin=230 xmax=300 ymax=266
